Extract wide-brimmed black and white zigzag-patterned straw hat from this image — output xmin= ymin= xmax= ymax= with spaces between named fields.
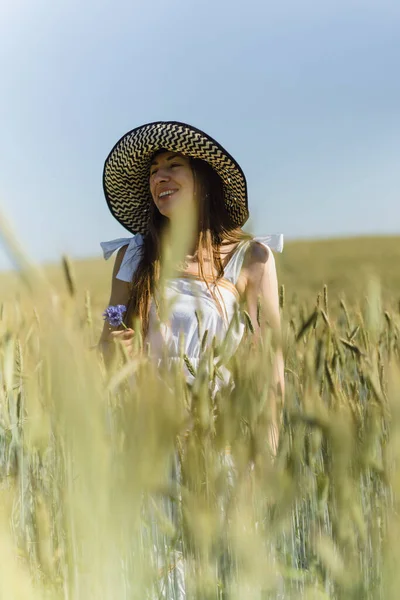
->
xmin=103 ymin=121 xmax=249 ymax=234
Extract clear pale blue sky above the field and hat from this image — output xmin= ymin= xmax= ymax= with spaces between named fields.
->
xmin=0 ymin=0 xmax=400 ymax=268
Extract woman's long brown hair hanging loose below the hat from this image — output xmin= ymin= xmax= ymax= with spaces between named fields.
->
xmin=126 ymin=150 xmax=251 ymax=336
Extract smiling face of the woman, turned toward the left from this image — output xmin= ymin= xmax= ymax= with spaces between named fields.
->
xmin=150 ymin=151 xmax=196 ymax=219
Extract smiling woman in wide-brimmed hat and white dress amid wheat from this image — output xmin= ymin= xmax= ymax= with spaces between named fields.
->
xmin=101 ymin=122 xmax=284 ymax=412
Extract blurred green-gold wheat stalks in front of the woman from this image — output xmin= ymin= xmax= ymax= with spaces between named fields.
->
xmin=0 ymin=237 xmax=400 ymax=600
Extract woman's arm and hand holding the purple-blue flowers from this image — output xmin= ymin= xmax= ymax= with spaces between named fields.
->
xmin=99 ymin=246 xmax=133 ymax=366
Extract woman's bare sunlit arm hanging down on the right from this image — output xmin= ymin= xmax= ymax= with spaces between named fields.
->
xmin=245 ymin=243 xmax=285 ymax=453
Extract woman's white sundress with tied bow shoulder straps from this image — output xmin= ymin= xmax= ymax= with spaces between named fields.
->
xmin=101 ymin=234 xmax=283 ymax=389
